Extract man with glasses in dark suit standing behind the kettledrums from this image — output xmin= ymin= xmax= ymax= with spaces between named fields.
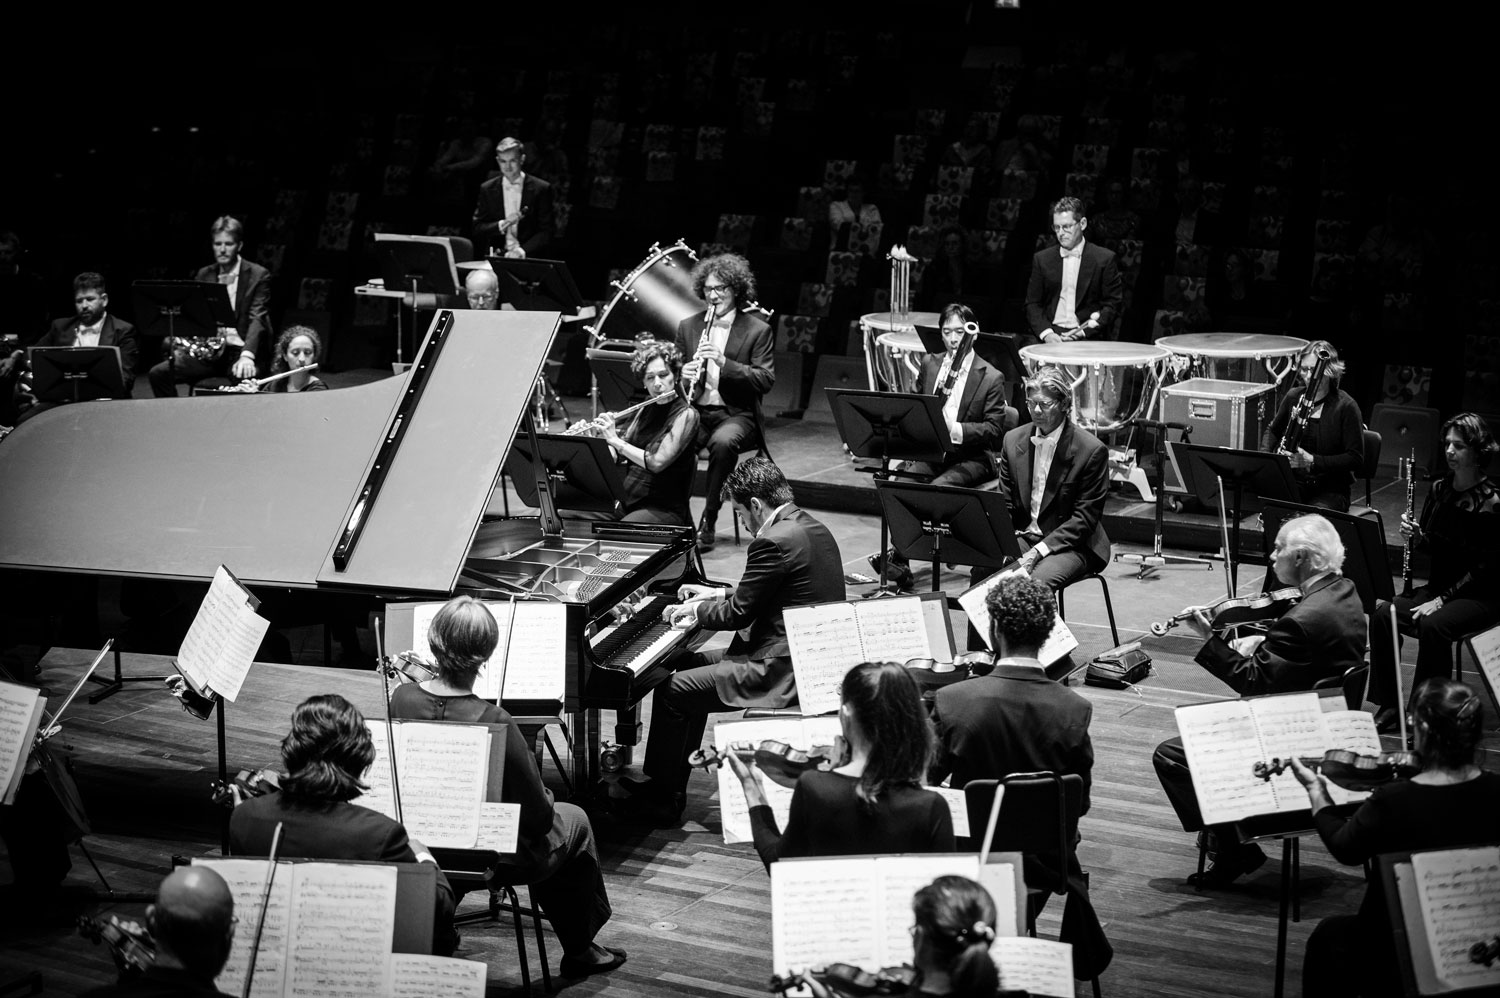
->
xmin=1026 ymin=198 xmax=1125 ymax=344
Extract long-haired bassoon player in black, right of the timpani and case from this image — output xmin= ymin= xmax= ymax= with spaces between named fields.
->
xmin=1260 ymin=339 xmax=1365 ymax=513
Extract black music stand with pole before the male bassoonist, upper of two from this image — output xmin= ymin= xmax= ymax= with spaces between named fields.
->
xmin=825 ymin=389 xmax=953 ymax=593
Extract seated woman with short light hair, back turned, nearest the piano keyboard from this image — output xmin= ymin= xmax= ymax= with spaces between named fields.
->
xmin=390 ymin=596 xmax=626 ymax=977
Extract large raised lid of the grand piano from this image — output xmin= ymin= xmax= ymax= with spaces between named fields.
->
xmin=0 ymin=311 xmax=560 ymax=594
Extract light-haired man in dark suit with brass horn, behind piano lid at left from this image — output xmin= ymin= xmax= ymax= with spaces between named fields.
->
xmin=147 ymin=215 xmax=272 ymax=398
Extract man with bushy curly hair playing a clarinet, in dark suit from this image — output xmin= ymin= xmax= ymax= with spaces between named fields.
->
xmin=677 ymin=254 xmax=776 ymax=548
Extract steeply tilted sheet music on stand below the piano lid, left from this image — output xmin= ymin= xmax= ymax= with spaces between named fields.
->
xmin=177 ymin=564 xmax=270 ymax=704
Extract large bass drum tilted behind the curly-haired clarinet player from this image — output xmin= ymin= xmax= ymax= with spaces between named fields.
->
xmin=588 ymin=240 xmax=708 ymax=353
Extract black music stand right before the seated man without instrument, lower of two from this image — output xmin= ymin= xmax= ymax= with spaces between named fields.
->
xmin=875 ymin=479 xmax=1022 ymax=593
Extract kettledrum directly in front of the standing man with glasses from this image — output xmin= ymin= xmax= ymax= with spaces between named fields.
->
xmin=1020 ymin=339 xmax=1172 ymax=434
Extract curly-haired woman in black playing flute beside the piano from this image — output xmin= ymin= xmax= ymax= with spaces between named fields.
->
xmin=570 ymin=339 xmax=699 ymax=527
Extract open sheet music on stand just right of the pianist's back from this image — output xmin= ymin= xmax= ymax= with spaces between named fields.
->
xmin=782 ymin=594 xmax=953 ymax=714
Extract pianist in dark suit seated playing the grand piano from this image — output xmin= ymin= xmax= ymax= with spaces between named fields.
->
xmin=620 ymin=458 xmax=845 ymax=824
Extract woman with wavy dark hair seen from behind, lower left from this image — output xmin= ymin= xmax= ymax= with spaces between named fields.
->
xmin=230 ymin=693 xmax=459 ymax=956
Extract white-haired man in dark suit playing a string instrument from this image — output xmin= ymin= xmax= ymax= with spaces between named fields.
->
xmin=1152 ymin=513 xmax=1365 ymax=887
